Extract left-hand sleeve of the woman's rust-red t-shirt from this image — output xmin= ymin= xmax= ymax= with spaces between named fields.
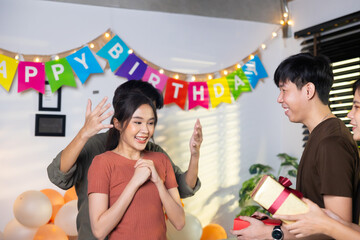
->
xmin=88 ymin=155 xmax=110 ymax=195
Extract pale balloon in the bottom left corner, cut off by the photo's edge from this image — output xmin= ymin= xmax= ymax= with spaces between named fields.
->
xmin=0 ymin=218 xmax=38 ymax=240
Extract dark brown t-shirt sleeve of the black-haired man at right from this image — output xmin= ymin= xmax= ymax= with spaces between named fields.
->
xmin=317 ymin=137 xmax=355 ymax=197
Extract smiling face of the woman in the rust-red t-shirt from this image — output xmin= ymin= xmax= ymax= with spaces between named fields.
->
xmin=120 ymin=104 xmax=155 ymax=151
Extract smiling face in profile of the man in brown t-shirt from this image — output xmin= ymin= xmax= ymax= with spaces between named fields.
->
xmin=277 ymin=81 xmax=307 ymax=123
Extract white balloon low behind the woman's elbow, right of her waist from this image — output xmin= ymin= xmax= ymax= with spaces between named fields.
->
xmin=166 ymin=213 xmax=202 ymax=240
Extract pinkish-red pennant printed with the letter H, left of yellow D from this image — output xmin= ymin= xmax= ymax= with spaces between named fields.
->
xmin=188 ymin=82 xmax=209 ymax=110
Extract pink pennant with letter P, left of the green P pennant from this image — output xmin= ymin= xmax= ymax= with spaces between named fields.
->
xmin=18 ymin=62 xmax=45 ymax=94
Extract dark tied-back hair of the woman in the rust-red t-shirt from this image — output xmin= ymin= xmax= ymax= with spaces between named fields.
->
xmin=106 ymin=91 xmax=157 ymax=150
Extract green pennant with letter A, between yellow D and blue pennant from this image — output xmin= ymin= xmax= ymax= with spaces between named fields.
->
xmin=226 ymin=68 xmax=251 ymax=100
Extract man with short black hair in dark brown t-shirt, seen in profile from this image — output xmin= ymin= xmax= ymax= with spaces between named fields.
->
xmin=232 ymin=53 xmax=360 ymax=239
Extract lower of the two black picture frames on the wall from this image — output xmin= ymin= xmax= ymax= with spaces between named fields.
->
xmin=35 ymin=114 xmax=66 ymax=137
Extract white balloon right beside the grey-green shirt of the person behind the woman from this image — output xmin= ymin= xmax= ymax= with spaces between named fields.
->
xmin=54 ymin=200 xmax=78 ymax=236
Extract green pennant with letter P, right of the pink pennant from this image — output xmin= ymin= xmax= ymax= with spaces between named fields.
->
xmin=45 ymin=58 xmax=76 ymax=92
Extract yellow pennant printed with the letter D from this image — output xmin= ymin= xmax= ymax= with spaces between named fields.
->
xmin=207 ymin=77 xmax=231 ymax=108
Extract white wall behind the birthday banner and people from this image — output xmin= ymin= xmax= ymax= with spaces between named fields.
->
xmin=0 ymin=0 xmax=359 ymax=237
